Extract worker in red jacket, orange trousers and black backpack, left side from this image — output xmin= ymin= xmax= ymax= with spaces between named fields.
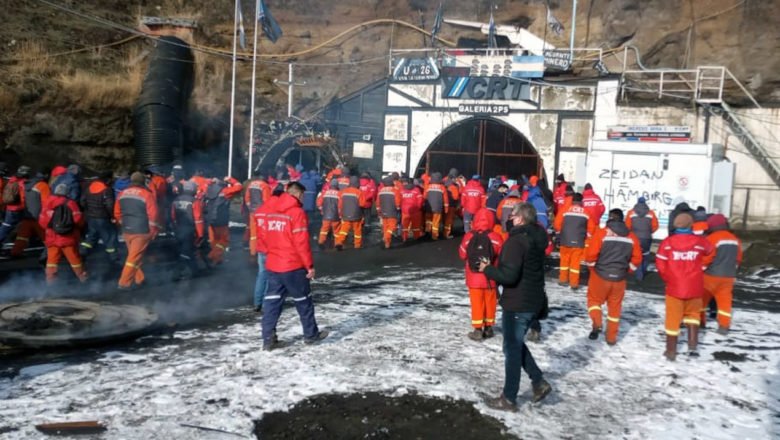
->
xmin=38 ymin=184 xmax=87 ymax=285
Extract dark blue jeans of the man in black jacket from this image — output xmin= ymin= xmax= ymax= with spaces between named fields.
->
xmin=501 ymin=310 xmax=542 ymax=403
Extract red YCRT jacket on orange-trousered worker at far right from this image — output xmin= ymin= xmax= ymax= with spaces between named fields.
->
xmin=655 ymin=233 xmax=713 ymax=299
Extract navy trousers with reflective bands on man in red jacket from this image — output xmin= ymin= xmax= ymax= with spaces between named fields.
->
xmin=262 ymin=269 xmax=320 ymax=345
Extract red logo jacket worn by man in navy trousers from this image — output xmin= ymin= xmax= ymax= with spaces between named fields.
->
xmin=258 ymin=193 xmax=314 ymax=272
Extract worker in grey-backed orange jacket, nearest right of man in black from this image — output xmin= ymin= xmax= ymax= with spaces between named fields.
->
xmin=585 ymin=209 xmax=642 ymax=345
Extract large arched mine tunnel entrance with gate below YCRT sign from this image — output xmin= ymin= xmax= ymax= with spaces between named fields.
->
xmin=415 ymin=118 xmax=542 ymax=178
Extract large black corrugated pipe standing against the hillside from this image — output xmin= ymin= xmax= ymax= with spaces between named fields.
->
xmin=133 ymin=36 xmax=194 ymax=168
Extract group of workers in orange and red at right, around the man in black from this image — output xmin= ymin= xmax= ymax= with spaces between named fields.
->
xmin=460 ymin=170 xmax=742 ymax=360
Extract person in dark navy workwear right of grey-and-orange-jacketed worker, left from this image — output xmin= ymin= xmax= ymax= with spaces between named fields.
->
xmin=171 ymin=180 xmax=205 ymax=279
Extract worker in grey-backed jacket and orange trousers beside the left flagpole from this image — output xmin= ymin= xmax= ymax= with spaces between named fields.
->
xmin=203 ymin=176 xmax=243 ymax=265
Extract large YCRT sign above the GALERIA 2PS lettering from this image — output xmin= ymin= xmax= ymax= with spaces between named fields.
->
xmin=441 ymin=76 xmax=531 ymax=101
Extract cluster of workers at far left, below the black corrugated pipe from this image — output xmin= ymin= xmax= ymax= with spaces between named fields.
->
xmin=0 ymin=164 xmax=242 ymax=290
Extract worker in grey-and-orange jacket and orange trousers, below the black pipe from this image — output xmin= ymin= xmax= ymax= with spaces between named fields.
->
xmin=114 ymin=171 xmax=160 ymax=290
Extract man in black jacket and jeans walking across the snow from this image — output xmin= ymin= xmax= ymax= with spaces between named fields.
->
xmin=479 ymin=203 xmax=552 ymax=411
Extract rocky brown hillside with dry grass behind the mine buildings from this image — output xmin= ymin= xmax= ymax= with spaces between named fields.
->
xmin=0 ymin=0 xmax=780 ymax=169
